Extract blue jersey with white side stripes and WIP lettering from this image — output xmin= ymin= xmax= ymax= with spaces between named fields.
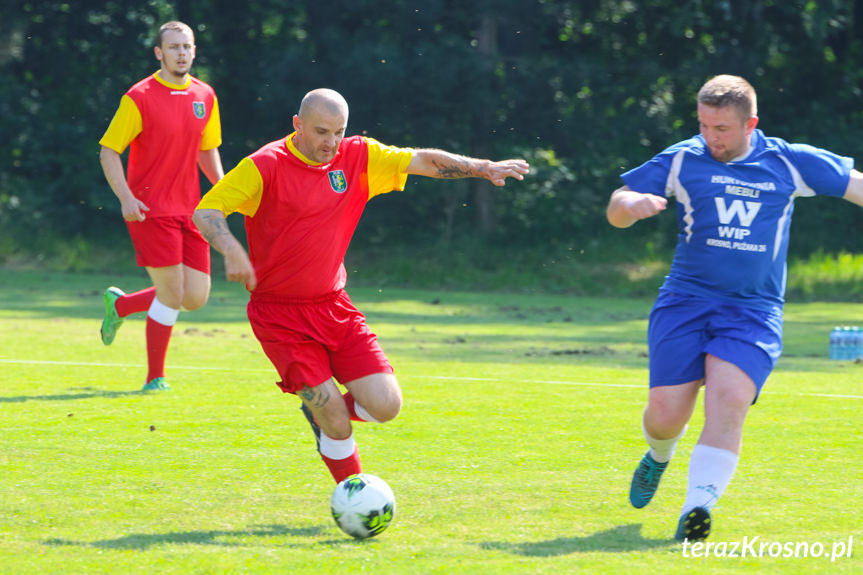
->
xmin=621 ymin=130 xmax=854 ymax=311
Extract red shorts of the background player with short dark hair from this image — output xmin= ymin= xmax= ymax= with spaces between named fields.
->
xmin=126 ymin=216 xmax=210 ymax=274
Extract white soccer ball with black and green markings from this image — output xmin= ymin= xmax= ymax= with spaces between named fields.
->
xmin=330 ymin=473 xmax=396 ymax=539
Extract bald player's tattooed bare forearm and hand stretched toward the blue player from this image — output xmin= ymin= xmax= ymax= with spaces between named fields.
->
xmin=407 ymin=149 xmax=530 ymax=186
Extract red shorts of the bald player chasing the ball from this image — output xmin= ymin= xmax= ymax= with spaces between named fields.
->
xmin=247 ymin=290 xmax=393 ymax=393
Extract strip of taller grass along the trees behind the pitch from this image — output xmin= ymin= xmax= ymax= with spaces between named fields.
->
xmin=10 ymin=238 xmax=863 ymax=303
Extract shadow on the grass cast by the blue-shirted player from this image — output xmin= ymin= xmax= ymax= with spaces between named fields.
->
xmin=480 ymin=523 xmax=677 ymax=557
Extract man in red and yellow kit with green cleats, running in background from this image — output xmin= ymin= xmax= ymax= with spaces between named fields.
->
xmin=99 ymin=22 xmax=224 ymax=391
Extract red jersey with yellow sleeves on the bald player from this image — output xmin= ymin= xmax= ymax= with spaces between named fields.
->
xmin=198 ymin=136 xmax=413 ymax=301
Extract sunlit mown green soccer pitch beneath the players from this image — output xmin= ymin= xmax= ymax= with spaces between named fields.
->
xmin=0 ymin=270 xmax=863 ymax=574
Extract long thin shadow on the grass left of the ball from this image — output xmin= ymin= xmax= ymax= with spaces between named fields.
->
xmin=44 ymin=525 xmax=330 ymax=550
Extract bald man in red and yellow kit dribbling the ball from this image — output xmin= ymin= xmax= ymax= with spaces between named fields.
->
xmin=193 ymin=89 xmax=528 ymax=483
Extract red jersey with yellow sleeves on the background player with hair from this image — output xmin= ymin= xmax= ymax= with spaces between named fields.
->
xmin=99 ymin=73 xmax=222 ymax=217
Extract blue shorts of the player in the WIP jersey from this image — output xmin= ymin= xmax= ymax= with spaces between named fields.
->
xmin=647 ymin=291 xmax=782 ymax=398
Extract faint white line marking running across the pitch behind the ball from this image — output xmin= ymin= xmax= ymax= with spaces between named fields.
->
xmin=0 ymin=358 xmax=863 ymax=399
